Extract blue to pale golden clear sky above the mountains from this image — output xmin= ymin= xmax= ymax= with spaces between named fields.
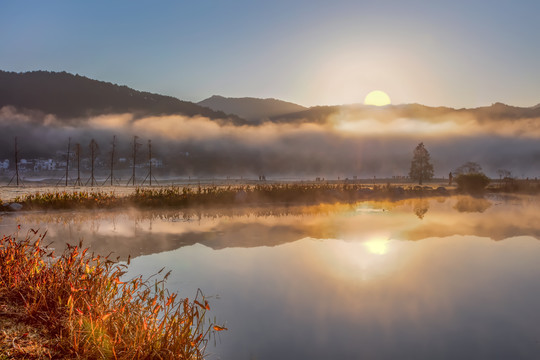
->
xmin=0 ymin=0 xmax=540 ymax=107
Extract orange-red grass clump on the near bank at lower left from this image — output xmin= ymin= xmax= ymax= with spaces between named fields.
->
xmin=0 ymin=233 xmax=225 ymax=359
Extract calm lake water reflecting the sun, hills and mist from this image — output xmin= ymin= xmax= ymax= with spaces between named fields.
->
xmin=0 ymin=196 xmax=540 ymax=360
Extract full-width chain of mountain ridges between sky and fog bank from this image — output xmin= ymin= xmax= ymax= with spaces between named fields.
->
xmin=0 ymin=70 xmax=540 ymax=125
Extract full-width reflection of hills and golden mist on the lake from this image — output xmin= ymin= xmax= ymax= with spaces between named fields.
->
xmin=7 ymin=196 xmax=540 ymax=259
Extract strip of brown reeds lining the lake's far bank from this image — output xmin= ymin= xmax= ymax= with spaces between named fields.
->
xmin=4 ymin=184 xmax=448 ymax=210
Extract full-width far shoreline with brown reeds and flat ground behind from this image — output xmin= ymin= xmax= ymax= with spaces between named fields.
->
xmin=0 ymin=180 xmax=540 ymax=212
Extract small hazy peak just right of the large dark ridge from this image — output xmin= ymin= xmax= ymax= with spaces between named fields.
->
xmin=198 ymin=95 xmax=307 ymax=121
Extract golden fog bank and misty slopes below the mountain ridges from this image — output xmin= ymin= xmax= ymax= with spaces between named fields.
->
xmin=0 ymin=103 xmax=540 ymax=178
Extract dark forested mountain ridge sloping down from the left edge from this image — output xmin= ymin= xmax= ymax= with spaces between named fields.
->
xmin=0 ymin=71 xmax=245 ymax=123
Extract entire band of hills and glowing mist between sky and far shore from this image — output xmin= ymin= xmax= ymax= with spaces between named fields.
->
xmin=0 ymin=71 xmax=540 ymax=178
